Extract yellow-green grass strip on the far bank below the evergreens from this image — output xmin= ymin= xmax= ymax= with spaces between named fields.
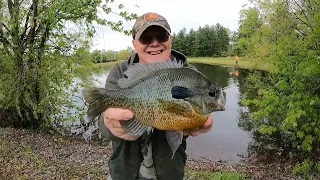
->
xmin=188 ymin=57 xmax=272 ymax=70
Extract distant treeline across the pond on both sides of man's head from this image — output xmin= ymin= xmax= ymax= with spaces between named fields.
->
xmin=91 ymin=23 xmax=238 ymax=59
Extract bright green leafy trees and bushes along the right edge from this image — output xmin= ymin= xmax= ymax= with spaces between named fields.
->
xmin=238 ymin=0 xmax=320 ymax=172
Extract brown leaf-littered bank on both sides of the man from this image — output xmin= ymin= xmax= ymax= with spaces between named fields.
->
xmin=0 ymin=128 xmax=312 ymax=179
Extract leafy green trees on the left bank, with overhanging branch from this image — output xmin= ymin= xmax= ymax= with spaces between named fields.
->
xmin=0 ymin=0 xmax=137 ymax=128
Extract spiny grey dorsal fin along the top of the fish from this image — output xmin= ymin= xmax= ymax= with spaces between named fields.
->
xmin=118 ymin=59 xmax=183 ymax=88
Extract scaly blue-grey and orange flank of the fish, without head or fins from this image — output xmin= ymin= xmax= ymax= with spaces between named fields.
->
xmin=107 ymin=69 xmax=206 ymax=130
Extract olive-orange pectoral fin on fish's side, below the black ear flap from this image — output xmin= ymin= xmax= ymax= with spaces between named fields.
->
xmin=158 ymin=99 xmax=191 ymax=116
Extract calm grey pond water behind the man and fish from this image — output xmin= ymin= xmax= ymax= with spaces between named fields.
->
xmin=67 ymin=64 xmax=252 ymax=163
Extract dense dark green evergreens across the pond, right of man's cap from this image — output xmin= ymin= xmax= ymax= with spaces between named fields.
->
xmin=172 ymin=24 xmax=231 ymax=57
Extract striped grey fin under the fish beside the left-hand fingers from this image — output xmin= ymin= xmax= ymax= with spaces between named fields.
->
xmin=120 ymin=119 xmax=153 ymax=136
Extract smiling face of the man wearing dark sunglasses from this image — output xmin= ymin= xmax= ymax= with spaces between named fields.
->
xmin=133 ymin=26 xmax=172 ymax=64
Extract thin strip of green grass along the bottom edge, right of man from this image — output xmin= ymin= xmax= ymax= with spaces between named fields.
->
xmin=186 ymin=170 xmax=250 ymax=180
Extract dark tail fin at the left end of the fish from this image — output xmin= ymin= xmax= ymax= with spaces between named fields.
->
xmin=82 ymin=88 xmax=108 ymax=120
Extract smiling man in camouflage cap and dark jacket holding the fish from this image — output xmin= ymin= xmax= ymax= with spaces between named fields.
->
xmin=99 ymin=13 xmax=212 ymax=180
